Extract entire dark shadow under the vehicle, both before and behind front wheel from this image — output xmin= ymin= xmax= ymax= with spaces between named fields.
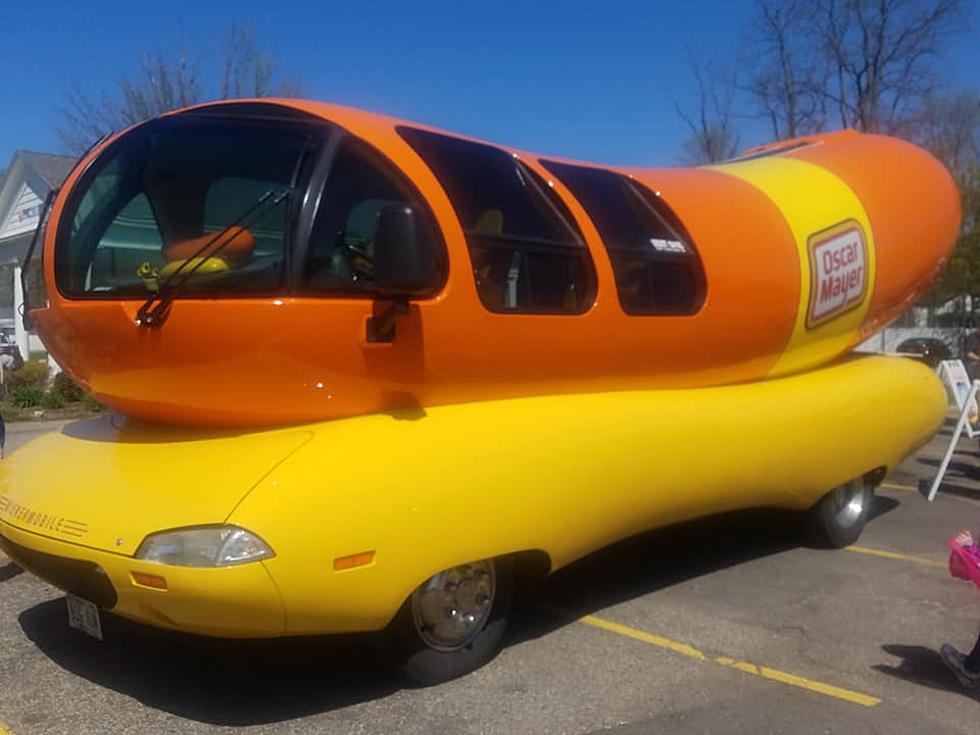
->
xmin=19 ymin=497 xmax=899 ymax=727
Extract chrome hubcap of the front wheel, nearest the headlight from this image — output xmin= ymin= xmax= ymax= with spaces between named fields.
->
xmin=412 ymin=560 xmax=497 ymax=651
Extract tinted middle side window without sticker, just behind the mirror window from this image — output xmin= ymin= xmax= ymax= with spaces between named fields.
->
xmin=398 ymin=128 xmax=596 ymax=314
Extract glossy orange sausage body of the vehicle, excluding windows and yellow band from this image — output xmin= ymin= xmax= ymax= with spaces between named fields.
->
xmin=32 ymin=100 xmax=960 ymax=426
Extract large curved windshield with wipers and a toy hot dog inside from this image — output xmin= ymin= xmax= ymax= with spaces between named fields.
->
xmin=55 ymin=117 xmax=316 ymax=298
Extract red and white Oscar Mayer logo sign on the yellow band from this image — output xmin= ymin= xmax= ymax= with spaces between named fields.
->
xmin=806 ymin=219 xmax=868 ymax=329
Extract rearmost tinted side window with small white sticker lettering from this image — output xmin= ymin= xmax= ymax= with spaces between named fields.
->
xmin=542 ymin=161 xmax=705 ymax=315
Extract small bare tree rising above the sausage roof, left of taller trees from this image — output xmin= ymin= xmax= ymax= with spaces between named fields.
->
xmin=672 ymin=54 xmax=739 ymax=164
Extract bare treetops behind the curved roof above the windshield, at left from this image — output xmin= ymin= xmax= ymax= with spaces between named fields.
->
xmin=55 ymin=21 xmax=301 ymax=154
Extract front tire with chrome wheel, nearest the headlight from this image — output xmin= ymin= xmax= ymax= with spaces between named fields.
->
xmin=379 ymin=559 xmax=514 ymax=686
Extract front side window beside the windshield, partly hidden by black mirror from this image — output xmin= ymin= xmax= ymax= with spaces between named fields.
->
xmin=302 ymin=140 xmax=442 ymax=294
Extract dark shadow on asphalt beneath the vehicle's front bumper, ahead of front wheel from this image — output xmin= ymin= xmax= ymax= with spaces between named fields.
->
xmin=19 ymin=598 xmax=401 ymax=727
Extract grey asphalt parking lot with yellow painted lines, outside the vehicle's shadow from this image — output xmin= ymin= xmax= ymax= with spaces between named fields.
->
xmin=0 ymin=416 xmax=980 ymax=735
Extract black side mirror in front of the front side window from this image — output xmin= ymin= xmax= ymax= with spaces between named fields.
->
xmin=374 ymin=204 xmax=440 ymax=298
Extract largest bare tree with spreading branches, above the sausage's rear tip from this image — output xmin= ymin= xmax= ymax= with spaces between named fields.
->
xmin=813 ymin=0 xmax=966 ymax=133
